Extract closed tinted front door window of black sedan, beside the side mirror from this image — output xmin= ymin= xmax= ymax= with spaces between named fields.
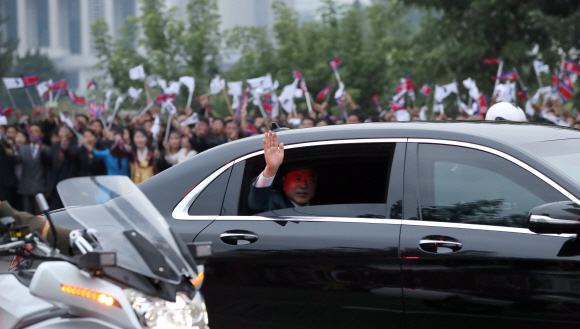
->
xmin=418 ymin=144 xmax=567 ymax=227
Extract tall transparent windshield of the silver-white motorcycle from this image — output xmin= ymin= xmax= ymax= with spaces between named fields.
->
xmin=57 ymin=176 xmax=196 ymax=284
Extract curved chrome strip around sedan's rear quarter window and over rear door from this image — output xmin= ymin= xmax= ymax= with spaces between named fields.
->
xmin=171 ymin=138 xmax=407 ymax=220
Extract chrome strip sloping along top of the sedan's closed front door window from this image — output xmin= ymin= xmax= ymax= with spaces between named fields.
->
xmin=408 ymin=138 xmax=580 ymax=204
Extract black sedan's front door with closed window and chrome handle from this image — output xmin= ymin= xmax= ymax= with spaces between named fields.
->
xmin=401 ymin=141 xmax=580 ymax=328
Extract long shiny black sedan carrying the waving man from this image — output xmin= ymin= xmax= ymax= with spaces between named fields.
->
xmin=71 ymin=123 xmax=580 ymax=329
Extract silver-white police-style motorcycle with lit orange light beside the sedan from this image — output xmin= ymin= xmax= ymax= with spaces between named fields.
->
xmin=0 ymin=176 xmax=211 ymax=329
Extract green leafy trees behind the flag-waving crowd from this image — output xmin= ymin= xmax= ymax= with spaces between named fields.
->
xmin=93 ymin=0 xmax=580 ymax=114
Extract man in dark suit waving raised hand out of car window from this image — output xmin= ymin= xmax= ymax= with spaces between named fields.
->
xmin=248 ymin=131 xmax=318 ymax=212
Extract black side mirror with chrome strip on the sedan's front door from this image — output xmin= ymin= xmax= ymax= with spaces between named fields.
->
xmin=528 ymin=201 xmax=580 ymax=234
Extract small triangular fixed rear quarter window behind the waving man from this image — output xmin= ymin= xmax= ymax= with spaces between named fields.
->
xmin=188 ymin=168 xmax=232 ymax=216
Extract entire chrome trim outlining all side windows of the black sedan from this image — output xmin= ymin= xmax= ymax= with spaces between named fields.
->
xmin=171 ymin=138 xmax=580 ymax=220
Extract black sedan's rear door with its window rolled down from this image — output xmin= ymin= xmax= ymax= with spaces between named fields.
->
xmin=196 ymin=141 xmax=405 ymax=329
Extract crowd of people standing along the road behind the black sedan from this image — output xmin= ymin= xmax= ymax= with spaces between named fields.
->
xmin=0 ymin=88 xmax=580 ymax=214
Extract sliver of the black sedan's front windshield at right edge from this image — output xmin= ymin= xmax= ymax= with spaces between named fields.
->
xmin=522 ymin=139 xmax=580 ymax=184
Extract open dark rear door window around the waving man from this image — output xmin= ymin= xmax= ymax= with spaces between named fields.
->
xmin=239 ymin=143 xmax=395 ymax=218
